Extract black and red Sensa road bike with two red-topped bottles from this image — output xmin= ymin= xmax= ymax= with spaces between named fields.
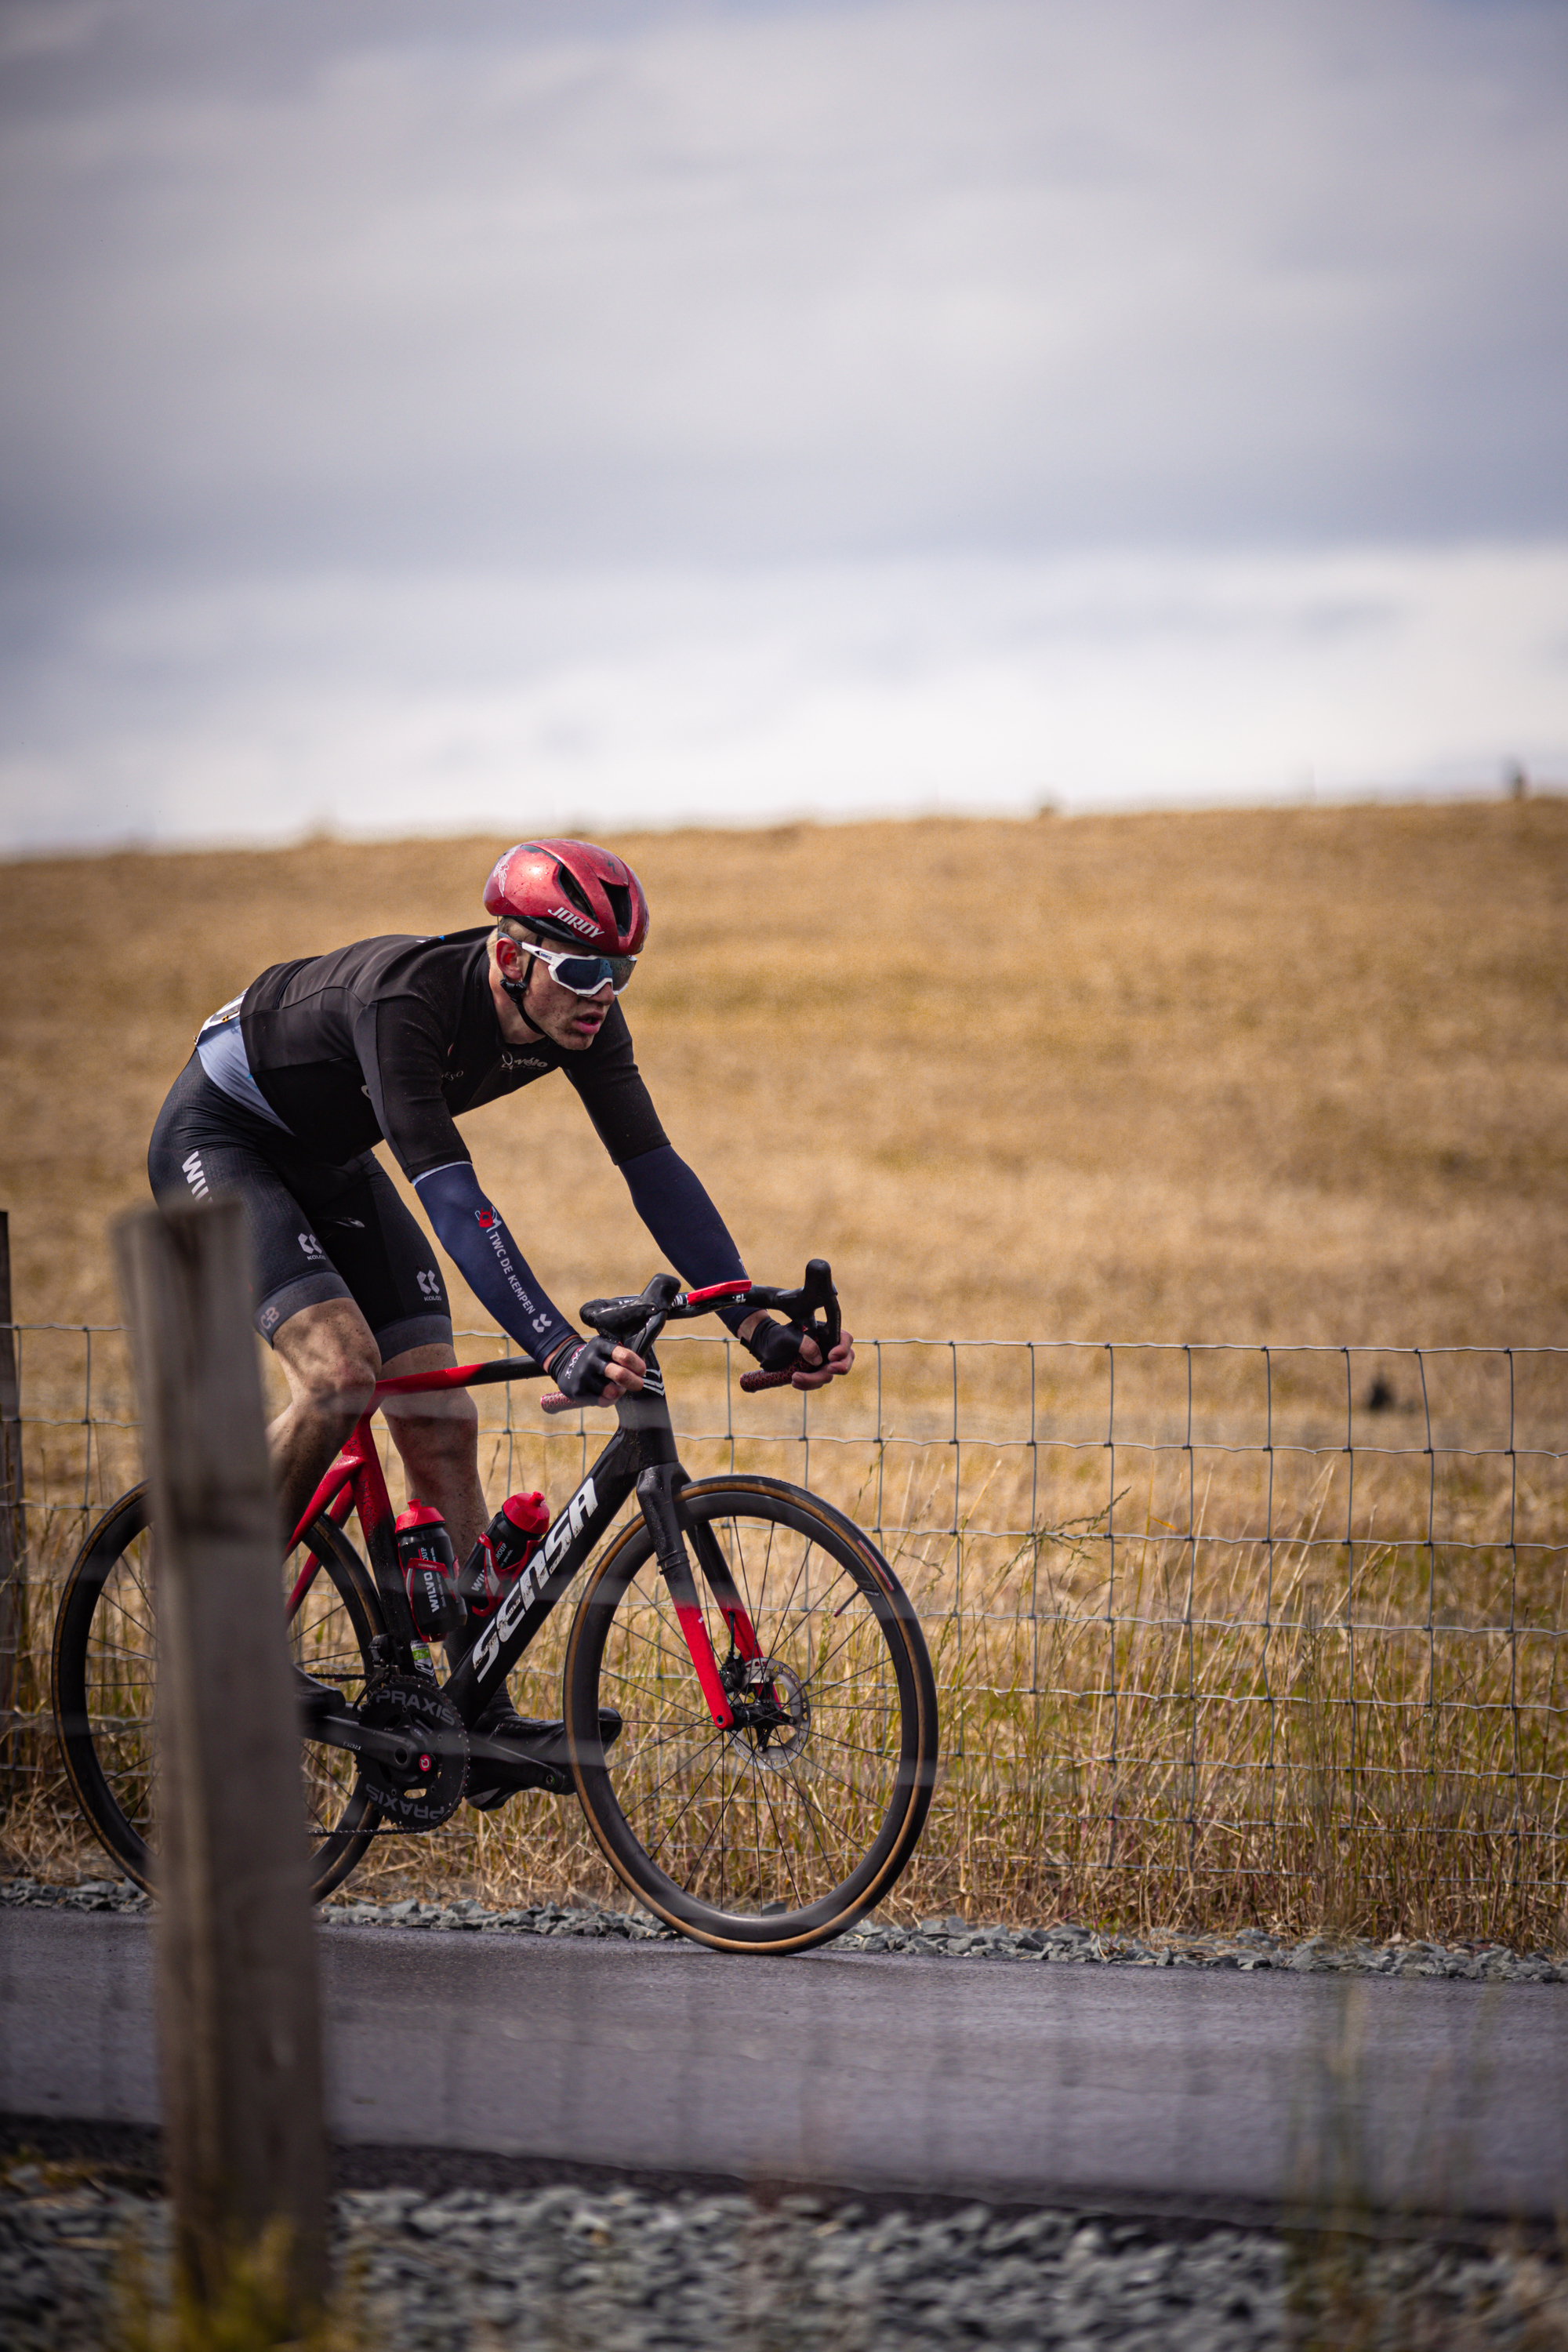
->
xmin=52 ymin=1258 xmax=938 ymax=1952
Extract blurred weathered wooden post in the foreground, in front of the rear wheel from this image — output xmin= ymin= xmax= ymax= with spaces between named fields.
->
xmin=115 ymin=1202 xmax=327 ymax=2321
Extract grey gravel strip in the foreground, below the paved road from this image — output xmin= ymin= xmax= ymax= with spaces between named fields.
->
xmin=0 ymin=2159 xmax=1568 ymax=2352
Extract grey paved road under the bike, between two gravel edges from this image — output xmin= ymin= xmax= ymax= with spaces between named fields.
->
xmin=0 ymin=1910 xmax=1568 ymax=2216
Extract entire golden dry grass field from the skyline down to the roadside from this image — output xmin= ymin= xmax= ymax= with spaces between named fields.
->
xmin=0 ymin=800 xmax=1568 ymax=1940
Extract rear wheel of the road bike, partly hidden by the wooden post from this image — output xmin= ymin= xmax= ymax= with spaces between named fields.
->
xmin=49 ymin=1486 xmax=381 ymax=1903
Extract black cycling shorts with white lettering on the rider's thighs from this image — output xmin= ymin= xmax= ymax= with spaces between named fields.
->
xmin=148 ymin=1054 xmax=452 ymax=1364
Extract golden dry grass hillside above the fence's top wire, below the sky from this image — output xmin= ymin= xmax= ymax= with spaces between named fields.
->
xmin=0 ymin=800 xmax=1568 ymax=1345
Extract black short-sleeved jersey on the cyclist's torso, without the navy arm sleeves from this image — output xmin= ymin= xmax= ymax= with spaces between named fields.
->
xmin=240 ymin=924 xmax=666 ymax=1178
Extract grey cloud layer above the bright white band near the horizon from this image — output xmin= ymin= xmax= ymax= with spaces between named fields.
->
xmin=0 ymin=0 xmax=1568 ymax=569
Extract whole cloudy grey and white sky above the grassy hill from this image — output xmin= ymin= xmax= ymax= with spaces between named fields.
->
xmin=0 ymin=0 xmax=1568 ymax=849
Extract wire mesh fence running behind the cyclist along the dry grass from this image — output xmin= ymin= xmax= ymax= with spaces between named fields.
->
xmin=0 ymin=1324 xmax=1568 ymax=1943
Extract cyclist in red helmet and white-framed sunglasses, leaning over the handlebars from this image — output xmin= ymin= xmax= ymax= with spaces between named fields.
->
xmin=148 ymin=840 xmax=853 ymax=1788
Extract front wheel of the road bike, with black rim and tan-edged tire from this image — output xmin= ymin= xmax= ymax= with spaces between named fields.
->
xmin=564 ymin=1477 xmax=938 ymax=1952
